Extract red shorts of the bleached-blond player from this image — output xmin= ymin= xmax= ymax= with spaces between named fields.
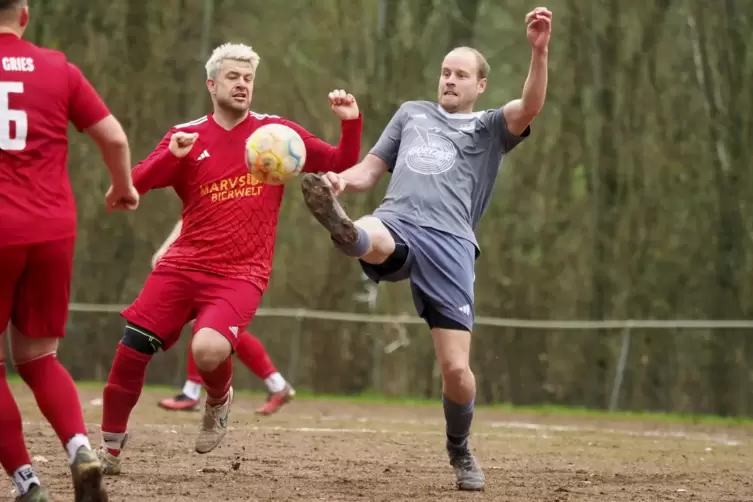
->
xmin=121 ymin=265 xmax=262 ymax=350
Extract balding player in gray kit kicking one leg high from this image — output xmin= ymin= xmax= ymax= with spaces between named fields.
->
xmin=301 ymin=7 xmax=552 ymax=490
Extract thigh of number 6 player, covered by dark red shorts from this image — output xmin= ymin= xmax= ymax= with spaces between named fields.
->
xmin=11 ymin=237 xmax=76 ymax=340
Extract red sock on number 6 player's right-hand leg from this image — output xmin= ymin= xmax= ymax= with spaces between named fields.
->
xmin=16 ymin=354 xmax=88 ymax=447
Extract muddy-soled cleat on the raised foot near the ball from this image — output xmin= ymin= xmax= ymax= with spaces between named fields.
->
xmin=301 ymin=173 xmax=358 ymax=246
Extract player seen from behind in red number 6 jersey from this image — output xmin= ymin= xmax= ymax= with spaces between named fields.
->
xmin=0 ymin=0 xmax=139 ymax=502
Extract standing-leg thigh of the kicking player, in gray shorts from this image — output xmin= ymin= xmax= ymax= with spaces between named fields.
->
xmin=411 ymin=230 xmax=475 ymax=332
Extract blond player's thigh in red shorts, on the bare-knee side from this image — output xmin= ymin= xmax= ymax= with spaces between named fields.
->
xmin=193 ymin=276 xmax=263 ymax=351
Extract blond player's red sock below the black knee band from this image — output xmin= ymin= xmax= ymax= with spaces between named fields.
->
xmin=102 ymin=342 xmax=152 ymax=440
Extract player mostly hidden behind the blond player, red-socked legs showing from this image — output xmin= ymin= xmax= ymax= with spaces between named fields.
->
xmin=152 ymin=220 xmax=295 ymax=415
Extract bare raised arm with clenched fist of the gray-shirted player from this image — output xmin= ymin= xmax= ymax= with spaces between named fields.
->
xmin=502 ymin=7 xmax=552 ymax=136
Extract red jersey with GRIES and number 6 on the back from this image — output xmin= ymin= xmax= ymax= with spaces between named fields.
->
xmin=0 ymin=33 xmax=110 ymax=246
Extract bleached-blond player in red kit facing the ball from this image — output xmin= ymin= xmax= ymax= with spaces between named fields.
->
xmin=92 ymin=40 xmax=363 ymax=474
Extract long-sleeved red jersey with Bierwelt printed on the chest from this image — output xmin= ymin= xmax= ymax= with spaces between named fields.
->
xmin=133 ymin=113 xmax=363 ymax=291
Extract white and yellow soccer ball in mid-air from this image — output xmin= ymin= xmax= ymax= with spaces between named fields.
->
xmin=246 ymin=124 xmax=306 ymax=185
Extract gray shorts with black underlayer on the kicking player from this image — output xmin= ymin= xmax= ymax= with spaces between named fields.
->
xmin=361 ymin=216 xmax=476 ymax=331
